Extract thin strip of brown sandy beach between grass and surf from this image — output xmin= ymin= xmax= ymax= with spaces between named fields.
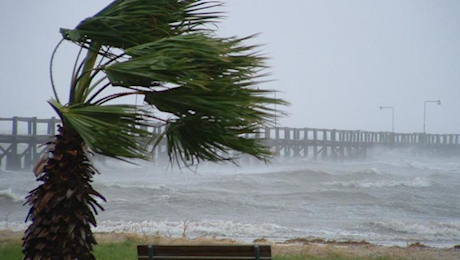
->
xmin=0 ymin=231 xmax=460 ymax=260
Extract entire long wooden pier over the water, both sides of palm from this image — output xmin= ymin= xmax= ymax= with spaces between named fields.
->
xmin=0 ymin=117 xmax=460 ymax=170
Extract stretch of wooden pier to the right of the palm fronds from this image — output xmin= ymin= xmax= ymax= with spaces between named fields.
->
xmin=261 ymin=127 xmax=460 ymax=160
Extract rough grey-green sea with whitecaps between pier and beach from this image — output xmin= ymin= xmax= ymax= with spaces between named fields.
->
xmin=0 ymin=153 xmax=460 ymax=247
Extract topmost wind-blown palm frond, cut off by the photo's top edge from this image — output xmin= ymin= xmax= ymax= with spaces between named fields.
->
xmin=61 ymin=0 xmax=221 ymax=49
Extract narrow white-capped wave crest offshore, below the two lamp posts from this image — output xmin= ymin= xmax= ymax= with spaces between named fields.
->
xmin=322 ymin=177 xmax=433 ymax=188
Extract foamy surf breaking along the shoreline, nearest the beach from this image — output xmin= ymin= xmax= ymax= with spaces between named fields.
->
xmin=0 ymin=220 xmax=460 ymax=247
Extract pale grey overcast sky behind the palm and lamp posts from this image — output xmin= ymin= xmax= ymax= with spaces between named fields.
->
xmin=0 ymin=0 xmax=460 ymax=133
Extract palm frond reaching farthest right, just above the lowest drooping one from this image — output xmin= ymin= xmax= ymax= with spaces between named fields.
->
xmin=144 ymin=79 xmax=286 ymax=123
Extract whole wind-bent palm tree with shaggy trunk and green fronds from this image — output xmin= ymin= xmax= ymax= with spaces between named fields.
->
xmin=23 ymin=0 xmax=285 ymax=259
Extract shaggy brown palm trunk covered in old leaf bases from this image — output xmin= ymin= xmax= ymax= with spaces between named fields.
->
xmin=23 ymin=127 xmax=105 ymax=260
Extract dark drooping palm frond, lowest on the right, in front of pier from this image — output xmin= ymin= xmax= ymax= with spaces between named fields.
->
xmin=159 ymin=115 xmax=271 ymax=164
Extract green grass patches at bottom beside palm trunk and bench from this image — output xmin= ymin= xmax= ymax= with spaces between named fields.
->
xmin=0 ymin=240 xmax=404 ymax=260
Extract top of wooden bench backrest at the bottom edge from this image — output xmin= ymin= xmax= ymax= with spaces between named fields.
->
xmin=137 ymin=245 xmax=272 ymax=260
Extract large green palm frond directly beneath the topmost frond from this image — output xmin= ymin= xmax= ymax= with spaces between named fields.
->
xmin=104 ymin=34 xmax=264 ymax=89
